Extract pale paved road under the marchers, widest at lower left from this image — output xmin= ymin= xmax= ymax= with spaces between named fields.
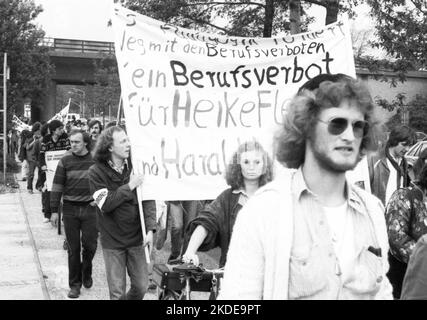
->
xmin=0 ymin=170 xmax=219 ymax=300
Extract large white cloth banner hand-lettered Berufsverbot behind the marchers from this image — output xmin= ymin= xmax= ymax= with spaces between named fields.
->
xmin=113 ymin=6 xmax=356 ymax=200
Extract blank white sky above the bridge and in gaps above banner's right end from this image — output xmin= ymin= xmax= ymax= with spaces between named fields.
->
xmin=34 ymin=0 xmax=371 ymax=42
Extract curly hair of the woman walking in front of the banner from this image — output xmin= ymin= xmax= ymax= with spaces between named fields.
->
xmin=225 ymin=140 xmax=273 ymax=190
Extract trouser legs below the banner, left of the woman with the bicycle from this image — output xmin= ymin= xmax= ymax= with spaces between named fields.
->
xmin=169 ymin=200 xmax=203 ymax=259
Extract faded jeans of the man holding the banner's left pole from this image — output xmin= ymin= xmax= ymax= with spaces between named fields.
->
xmin=102 ymin=245 xmax=148 ymax=300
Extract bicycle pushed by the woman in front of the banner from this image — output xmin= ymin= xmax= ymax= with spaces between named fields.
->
xmin=153 ymin=261 xmax=224 ymax=300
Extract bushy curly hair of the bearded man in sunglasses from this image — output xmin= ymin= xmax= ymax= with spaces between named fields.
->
xmin=275 ymin=77 xmax=378 ymax=168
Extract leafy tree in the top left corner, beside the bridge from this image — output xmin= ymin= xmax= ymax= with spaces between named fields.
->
xmin=0 ymin=0 xmax=53 ymax=123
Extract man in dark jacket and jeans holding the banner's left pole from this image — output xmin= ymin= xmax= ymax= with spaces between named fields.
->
xmin=89 ymin=126 xmax=156 ymax=300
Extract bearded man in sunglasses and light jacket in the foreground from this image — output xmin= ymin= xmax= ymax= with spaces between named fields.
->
xmin=219 ymin=75 xmax=392 ymax=300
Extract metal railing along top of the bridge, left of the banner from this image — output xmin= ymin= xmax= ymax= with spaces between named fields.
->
xmin=42 ymin=38 xmax=114 ymax=54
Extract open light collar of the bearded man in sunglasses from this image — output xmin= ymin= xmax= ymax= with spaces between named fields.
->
xmin=292 ymin=167 xmax=367 ymax=218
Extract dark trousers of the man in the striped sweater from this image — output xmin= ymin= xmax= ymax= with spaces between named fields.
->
xmin=62 ymin=202 xmax=98 ymax=288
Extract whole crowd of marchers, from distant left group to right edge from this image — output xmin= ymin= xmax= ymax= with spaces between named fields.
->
xmin=5 ymin=74 xmax=427 ymax=300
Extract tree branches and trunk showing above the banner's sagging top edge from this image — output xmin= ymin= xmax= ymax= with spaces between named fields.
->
xmin=122 ymin=0 xmax=361 ymax=37
